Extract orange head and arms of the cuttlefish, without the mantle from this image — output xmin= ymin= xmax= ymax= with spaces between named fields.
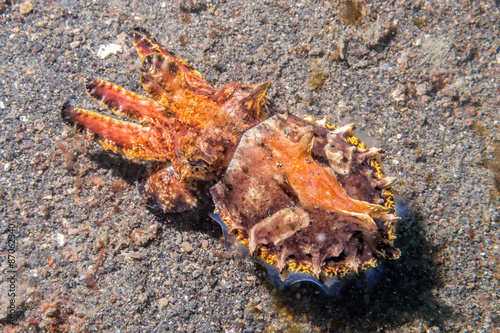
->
xmin=61 ymin=28 xmax=272 ymax=212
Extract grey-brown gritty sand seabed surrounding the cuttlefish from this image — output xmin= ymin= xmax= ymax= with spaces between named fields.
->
xmin=0 ymin=0 xmax=500 ymax=332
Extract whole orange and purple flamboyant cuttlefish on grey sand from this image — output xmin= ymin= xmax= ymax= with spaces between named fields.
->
xmin=61 ymin=28 xmax=399 ymax=293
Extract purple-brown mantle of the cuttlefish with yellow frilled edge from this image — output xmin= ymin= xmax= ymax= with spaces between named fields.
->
xmin=210 ymin=114 xmax=399 ymax=281
